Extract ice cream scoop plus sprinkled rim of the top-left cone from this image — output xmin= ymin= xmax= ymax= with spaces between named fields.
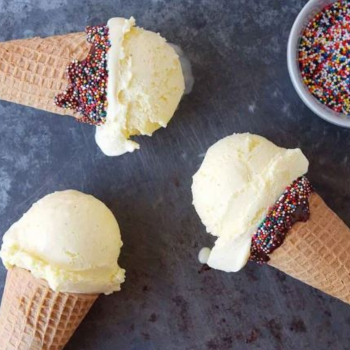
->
xmin=55 ymin=17 xmax=185 ymax=156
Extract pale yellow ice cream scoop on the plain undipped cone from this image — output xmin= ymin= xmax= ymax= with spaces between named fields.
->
xmin=0 ymin=190 xmax=125 ymax=294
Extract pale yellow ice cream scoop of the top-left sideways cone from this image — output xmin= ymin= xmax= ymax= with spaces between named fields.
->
xmin=96 ymin=18 xmax=185 ymax=156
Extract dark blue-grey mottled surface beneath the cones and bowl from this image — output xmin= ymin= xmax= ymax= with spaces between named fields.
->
xmin=0 ymin=0 xmax=350 ymax=350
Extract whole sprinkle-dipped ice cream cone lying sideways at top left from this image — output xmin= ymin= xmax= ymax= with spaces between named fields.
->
xmin=0 ymin=17 xmax=185 ymax=156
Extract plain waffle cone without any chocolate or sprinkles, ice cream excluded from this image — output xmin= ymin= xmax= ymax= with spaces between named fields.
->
xmin=0 ymin=268 xmax=98 ymax=350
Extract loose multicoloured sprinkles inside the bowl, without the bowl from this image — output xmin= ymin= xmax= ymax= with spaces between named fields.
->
xmin=299 ymin=0 xmax=350 ymax=115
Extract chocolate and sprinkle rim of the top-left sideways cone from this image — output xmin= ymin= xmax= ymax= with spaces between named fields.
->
xmin=55 ymin=26 xmax=111 ymax=125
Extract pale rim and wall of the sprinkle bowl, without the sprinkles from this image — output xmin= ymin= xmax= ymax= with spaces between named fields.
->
xmin=287 ymin=0 xmax=350 ymax=128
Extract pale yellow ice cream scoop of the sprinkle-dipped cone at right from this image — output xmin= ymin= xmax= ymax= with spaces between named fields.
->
xmin=192 ymin=133 xmax=309 ymax=272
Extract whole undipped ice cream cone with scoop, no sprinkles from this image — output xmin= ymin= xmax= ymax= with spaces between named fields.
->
xmin=0 ymin=190 xmax=125 ymax=350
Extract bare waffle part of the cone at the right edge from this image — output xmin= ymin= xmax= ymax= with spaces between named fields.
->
xmin=269 ymin=193 xmax=350 ymax=304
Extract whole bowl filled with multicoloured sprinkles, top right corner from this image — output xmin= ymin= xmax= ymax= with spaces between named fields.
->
xmin=287 ymin=0 xmax=350 ymax=128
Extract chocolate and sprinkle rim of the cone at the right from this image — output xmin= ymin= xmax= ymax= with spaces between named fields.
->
xmin=250 ymin=176 xmax=312 ymax=264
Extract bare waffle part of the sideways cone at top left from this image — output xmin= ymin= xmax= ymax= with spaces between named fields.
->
xmin=0 ymin=32 xmax=90 ymax=118
